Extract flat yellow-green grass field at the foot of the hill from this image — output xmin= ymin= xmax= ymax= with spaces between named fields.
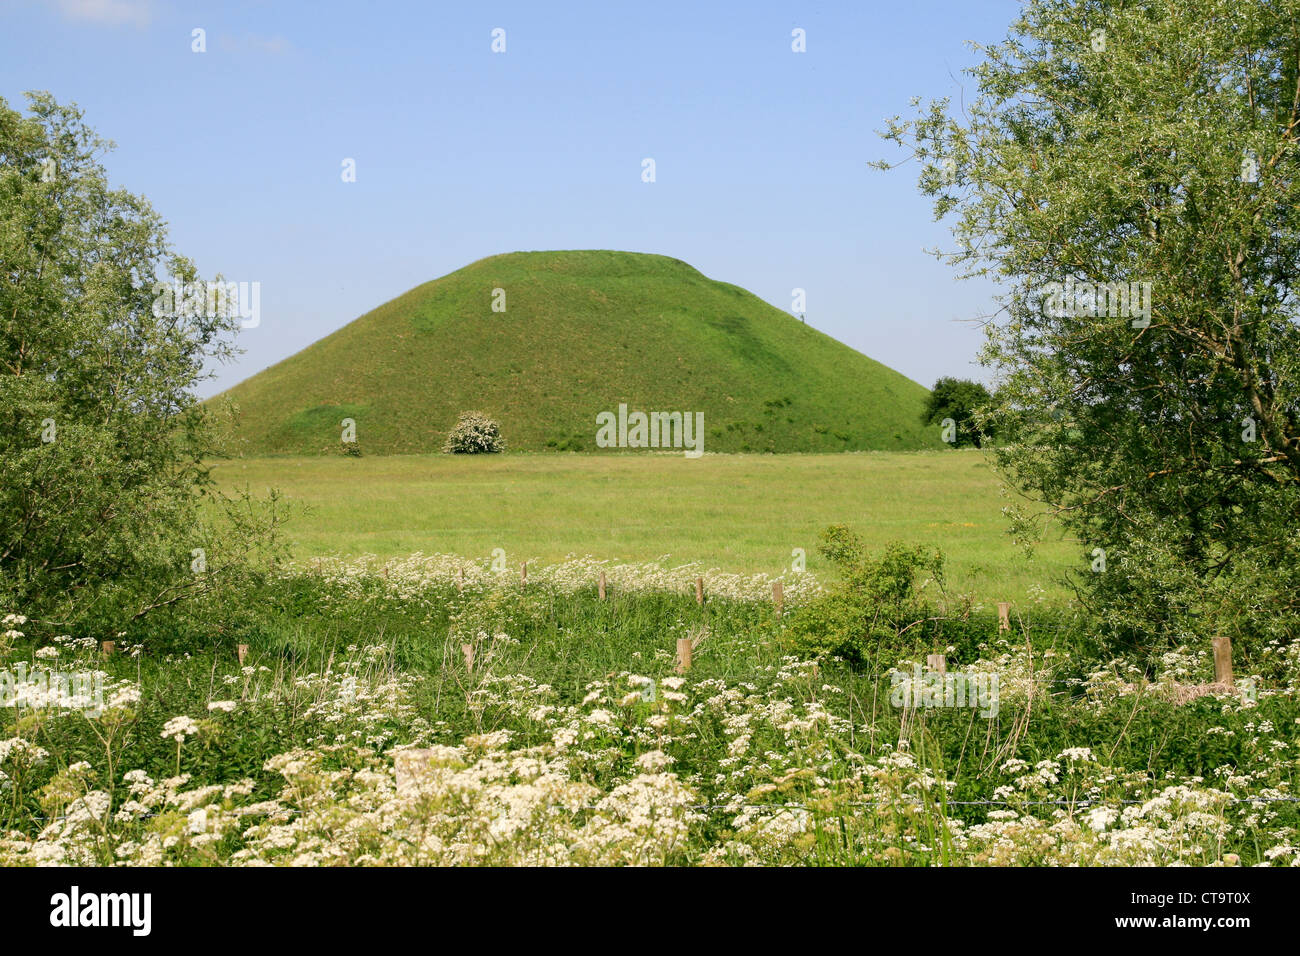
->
xmin=213 ymin=450 xmax=1083 ymax=601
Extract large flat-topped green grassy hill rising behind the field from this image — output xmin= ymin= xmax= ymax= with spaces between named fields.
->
xmin=213 ymin=251 xmax=939 ymax=454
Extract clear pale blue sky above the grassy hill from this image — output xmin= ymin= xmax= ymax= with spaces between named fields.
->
xmin=0 ymin=0 xmax=1019 ymax=395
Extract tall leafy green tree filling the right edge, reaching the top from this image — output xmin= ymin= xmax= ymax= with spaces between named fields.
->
xmin=881 ymin=0 xmax=1300 ymax=650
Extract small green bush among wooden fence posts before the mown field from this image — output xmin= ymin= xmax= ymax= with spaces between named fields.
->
xmin=790 ymin=524 xmax=944 ymax=665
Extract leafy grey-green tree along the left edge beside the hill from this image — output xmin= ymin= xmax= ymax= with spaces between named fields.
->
xmin=0 ymin=94 xmax=253 ymax=620
